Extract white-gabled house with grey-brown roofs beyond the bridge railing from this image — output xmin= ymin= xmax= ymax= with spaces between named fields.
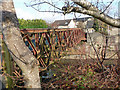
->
xmin=52 ymin=17 xmax=93 ymax=28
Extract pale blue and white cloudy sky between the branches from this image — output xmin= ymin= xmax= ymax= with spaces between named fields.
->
xmin=13 ymin=0 xmax=119 ymax=22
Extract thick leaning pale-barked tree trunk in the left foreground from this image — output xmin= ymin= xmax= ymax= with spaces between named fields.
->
xmin=2 ymin=0 xmax=41 ymax=88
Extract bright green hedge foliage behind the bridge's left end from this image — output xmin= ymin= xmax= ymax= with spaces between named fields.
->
xmin=18 ymin=19 xmax=48 ymax=29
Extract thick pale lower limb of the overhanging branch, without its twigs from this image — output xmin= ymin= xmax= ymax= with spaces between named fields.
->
xmin=62 ymin=7 xmax=120 ymax=28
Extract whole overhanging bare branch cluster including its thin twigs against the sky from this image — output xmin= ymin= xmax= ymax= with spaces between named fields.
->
xmin=26 ymin=0 xmax=120 ymax=28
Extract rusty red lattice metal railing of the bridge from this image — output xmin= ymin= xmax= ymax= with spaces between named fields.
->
xmin=21 ymin=28 xmax=86 ymax=67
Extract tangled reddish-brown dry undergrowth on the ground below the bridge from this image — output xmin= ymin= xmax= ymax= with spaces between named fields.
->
xmin=42 ymin=59 xmax=120 ymax=89
